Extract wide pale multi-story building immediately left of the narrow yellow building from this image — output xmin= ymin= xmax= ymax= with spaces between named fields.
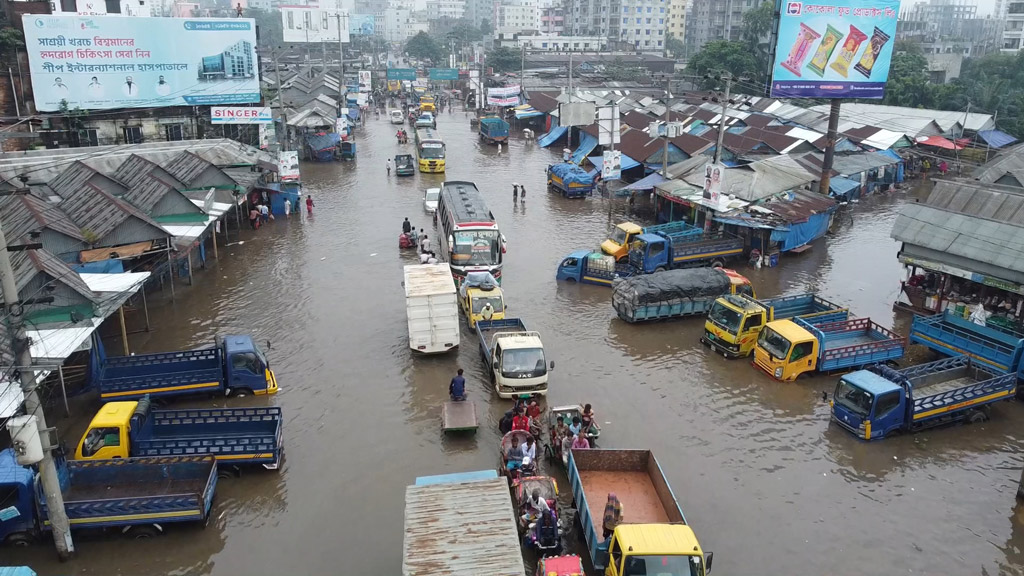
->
xmin=564 ymin=0 xmax=669 ymax=52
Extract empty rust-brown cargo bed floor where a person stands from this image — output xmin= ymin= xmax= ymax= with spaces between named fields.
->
xmin=580 ymin=470 xmax=669 ymax=524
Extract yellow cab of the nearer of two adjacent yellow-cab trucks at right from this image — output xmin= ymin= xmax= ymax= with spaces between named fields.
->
xmin=754 ymin=320 xmax=821 ymax=382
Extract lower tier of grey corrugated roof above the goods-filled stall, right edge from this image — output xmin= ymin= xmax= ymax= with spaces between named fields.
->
xmin=892 ymin=203 xmax=1024 ymax=281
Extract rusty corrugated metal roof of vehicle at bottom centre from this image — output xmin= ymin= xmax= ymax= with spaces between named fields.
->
xmin=401 ymin=478 xmax=525 ymax=576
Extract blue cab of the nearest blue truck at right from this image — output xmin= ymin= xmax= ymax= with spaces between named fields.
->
xmin=831 ymin=370 xmax=907 ymax=440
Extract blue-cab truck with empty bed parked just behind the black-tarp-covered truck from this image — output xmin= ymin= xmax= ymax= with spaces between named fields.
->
xmin=629 ymin=222 xmax=743 ymax=274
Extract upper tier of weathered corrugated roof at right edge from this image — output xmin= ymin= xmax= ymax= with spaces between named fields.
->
xmin=925 ymin=180 xmax=1024 ymax=228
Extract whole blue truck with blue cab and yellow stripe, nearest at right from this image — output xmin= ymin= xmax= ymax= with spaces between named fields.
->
xmin=831 ymin=356 xmax=1017 ymax=440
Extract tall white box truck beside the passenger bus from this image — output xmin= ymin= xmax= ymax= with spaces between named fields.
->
xmin=404 ymin=262 xmax=459 ymax=354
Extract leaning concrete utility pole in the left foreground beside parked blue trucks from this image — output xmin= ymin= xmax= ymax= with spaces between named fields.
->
xmin=0 ymin=215 xmax=75 ymax=561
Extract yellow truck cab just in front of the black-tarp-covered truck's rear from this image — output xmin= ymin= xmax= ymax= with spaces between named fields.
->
xmin=700 ymin=294 xmax=768 ymax=358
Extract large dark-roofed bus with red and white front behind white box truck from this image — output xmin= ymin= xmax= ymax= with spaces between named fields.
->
xmin=437 ymin=181 xmax=505 ymax=286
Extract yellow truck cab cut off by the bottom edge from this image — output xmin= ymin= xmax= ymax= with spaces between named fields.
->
xmin=604 ymin=524 xmax=713 ymax=576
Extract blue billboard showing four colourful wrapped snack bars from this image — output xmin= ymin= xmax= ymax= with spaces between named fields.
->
xmin=771 ymin=0 xmax=899 ymax=98
